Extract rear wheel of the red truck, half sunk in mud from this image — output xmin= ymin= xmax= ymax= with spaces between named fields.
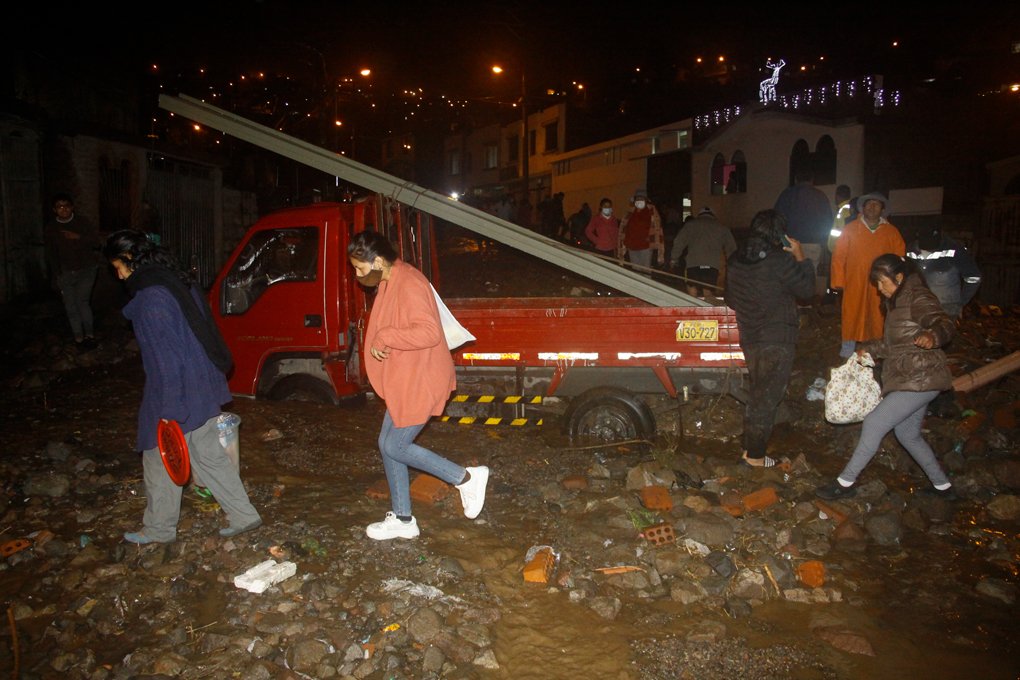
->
xmin=565 ymin=387 xmax=655 ymax=441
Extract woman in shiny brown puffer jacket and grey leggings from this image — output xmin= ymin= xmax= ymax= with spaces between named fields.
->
xmin=815 ymin=253 xmax=956 ymax=500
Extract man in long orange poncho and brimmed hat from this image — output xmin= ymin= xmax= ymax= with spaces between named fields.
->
xmin=830 ymin=193 xmax=907 ymax=359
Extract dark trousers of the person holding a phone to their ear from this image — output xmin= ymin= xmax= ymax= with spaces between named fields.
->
xmin=744 ymin=345 xmax=796 ymax=458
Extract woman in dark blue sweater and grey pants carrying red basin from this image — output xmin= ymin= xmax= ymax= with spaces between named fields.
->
xmin=103 ymin=229 xmax=262 ymax=545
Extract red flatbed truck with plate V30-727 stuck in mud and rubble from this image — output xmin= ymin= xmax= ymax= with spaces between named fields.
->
xmin=210 ymin=194 xmax=746 ymax=440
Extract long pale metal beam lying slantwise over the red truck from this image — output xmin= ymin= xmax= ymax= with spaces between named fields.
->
xmin=159 ymin=95 xmax=711 ymax=307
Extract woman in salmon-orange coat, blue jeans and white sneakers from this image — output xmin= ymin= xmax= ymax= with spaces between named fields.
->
xmin=347 ymin=231 xmax=489 ymax=540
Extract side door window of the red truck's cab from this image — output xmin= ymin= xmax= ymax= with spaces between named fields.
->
xmin=220 ymin=226 xmax=318 ymax=315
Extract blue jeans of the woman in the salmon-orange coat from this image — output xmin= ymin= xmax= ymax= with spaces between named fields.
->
xmin=379 ymin=410 xmax=466 ymax=517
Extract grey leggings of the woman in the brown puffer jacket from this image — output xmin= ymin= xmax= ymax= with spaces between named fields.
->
xmin=839 ymin=389 xmax=950 ymax=486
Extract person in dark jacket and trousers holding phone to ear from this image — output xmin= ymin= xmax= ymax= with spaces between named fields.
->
xmin=726 ymin=210 xmax=815 ymax=468
